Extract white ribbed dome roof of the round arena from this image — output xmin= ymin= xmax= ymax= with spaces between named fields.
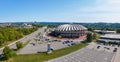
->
xmin=55 ymin=24 xmax=87 ymax=31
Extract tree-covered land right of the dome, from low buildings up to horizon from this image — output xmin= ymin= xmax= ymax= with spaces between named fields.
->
xmin=80 ymin=23 xmax=120 ymax=33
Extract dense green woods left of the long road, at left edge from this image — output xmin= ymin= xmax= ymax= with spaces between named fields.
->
xmin=0 ymin=27 xmax=37 ymax=46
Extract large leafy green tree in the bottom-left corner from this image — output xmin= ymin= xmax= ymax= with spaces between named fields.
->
xmin=3 ymin=46 xmax=13 ymax=60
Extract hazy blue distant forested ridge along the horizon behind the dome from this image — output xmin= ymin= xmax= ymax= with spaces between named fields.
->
xmin=40 ymin=22 xmax=120 ymax=28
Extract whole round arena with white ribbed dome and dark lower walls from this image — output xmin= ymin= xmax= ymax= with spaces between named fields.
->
xmin=50 ymin=24 xmax=87 ymax=38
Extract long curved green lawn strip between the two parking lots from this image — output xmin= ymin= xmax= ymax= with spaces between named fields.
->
xmin=11 ymin=44 xmax=87 ymax=62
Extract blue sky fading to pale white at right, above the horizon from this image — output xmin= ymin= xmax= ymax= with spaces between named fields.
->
xmin=0 ymin=0 xmax=120 ymax=23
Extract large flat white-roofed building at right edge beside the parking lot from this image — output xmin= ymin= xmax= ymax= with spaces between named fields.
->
xmin=98 ymin=34 xmax=120 ymax=43
